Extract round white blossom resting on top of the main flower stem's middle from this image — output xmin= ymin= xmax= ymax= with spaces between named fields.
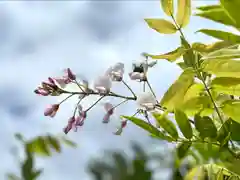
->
xmin=94 ymin=76 xmax=112 ymax=94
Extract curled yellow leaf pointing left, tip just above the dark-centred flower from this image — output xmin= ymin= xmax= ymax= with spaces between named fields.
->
xmin=144 ymin=47 xmax=185 ymax=62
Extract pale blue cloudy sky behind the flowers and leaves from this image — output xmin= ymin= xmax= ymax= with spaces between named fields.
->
xmin=0 ymin=0 xmax=231 ymax=180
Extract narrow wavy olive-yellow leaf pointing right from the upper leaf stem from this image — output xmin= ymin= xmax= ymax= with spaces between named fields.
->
xmin=192 ymin=41 xmax=233 ymax=53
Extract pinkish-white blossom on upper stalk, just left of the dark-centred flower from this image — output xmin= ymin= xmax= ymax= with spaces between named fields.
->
xmin=106 ymin=63 xmax=124 ymax=81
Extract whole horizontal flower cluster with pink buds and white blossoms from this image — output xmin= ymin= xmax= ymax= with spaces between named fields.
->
xmin=34 ymin=59 xmax=161 ymax=135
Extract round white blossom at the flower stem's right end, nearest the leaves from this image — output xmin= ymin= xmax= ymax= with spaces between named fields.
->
xmin=137 ymin=92 xmax=157 ymax=110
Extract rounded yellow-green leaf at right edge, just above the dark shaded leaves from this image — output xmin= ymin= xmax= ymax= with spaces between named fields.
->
xmin=221 ymin=100 xmax=240 ymax=123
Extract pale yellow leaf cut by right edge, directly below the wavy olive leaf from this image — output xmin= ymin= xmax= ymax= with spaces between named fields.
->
xmin=201 ymin=49 xmax=240 ymax=60
